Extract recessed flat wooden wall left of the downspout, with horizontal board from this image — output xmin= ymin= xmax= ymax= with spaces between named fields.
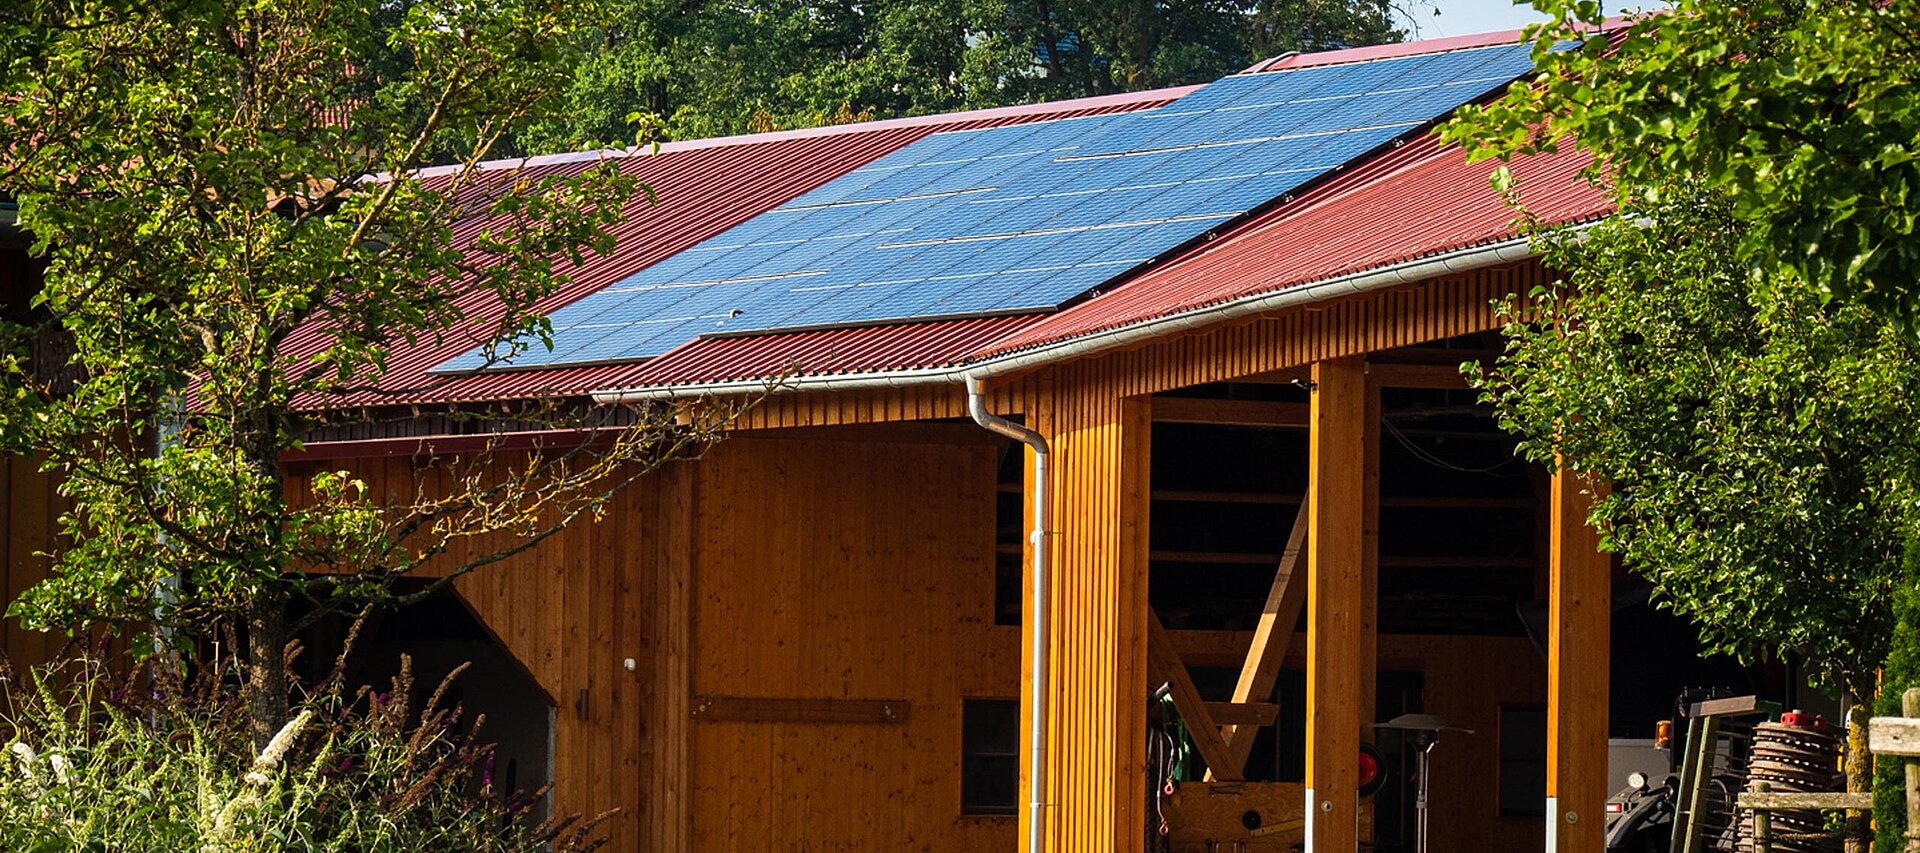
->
xmin=689 ymin=436 xmax=1020 ymax=853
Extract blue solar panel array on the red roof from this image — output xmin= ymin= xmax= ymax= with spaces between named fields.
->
xmin=438 ymin=44 xmax=1532 ymax=371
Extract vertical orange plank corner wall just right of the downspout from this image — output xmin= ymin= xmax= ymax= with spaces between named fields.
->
xmin=1021 ymin=361 xmax=1152 ymax=853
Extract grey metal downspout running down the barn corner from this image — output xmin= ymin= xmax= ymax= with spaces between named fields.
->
xmin=966 ymin=373 xmax=1048 ymax=853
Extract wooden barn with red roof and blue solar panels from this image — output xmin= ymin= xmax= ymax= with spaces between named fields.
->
xmin=0 ymin=33 xmax=1781 ymax=853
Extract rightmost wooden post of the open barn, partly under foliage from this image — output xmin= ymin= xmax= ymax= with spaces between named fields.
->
xmin=1546 ymin=467 xmax=1613 ymax=853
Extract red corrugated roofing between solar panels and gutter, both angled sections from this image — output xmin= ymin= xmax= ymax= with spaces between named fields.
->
xmin=622 ymin=136 xmax=1611 ymax=388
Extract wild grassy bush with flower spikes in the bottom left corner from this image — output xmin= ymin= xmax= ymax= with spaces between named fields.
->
xmin=0 ymin=653 xmax=605 ymax=853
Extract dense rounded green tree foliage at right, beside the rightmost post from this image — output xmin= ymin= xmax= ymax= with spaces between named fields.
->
xmin=1480 ymin=188 xmax=1920 ymax=695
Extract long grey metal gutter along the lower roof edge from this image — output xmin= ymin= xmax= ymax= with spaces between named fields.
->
xmin=591 ymin=233 xmax=1543 ymax=403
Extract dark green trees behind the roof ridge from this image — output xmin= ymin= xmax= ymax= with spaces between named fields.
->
xmin=522 ymin=0 xmax=1404 ymax=150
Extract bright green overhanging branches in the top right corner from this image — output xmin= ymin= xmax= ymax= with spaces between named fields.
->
xmin=1461 ymin=0 xmax=1920 ymax=323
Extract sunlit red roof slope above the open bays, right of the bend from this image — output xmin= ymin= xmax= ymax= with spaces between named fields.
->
xmin=973 ymin=136 xmax=1613 ymax=357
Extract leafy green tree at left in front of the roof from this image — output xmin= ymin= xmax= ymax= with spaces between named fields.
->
xmin=0 ymin=0 xmax=725 ymax=743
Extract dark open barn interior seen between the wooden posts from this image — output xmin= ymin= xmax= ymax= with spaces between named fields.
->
xmin=975 ymin=334 xmax=1784 ymax=853
